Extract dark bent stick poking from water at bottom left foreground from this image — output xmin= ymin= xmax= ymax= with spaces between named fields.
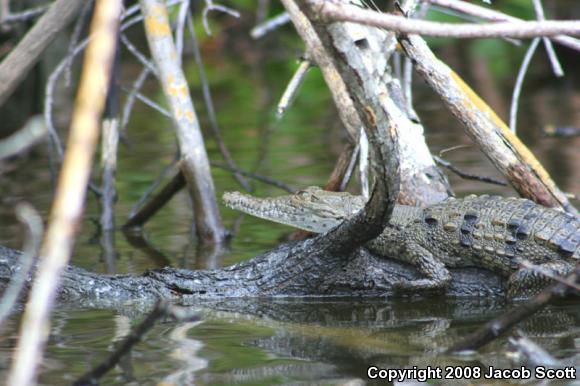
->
xmin=73 ymin=300 xmax=199 ymax=386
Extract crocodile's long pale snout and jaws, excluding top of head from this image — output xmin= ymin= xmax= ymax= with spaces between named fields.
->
xmin=223 ymin=191 xmax=351 ymax=233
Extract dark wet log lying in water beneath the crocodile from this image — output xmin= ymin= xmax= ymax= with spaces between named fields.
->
xmin=0 ymin=244 xmax=504 ymax=308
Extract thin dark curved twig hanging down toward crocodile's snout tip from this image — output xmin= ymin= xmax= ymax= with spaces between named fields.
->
xmin=187 ymin=14 xmax=252 ymax=192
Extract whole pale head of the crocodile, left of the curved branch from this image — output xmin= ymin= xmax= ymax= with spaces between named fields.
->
xmin=223 ymin=186 xmax=365 ymax=233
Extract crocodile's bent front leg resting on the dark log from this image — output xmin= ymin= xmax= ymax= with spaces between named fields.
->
xmin=393 ymin=242 xmax=451 ymax=293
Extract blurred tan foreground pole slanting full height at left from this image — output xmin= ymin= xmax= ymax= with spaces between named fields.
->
xmin=7 ymin=1 xmax=122 ymax=386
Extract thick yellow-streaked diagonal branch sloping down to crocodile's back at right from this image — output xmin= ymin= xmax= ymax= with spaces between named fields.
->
xmin=398 ymin=35 xmax=578 ymax=214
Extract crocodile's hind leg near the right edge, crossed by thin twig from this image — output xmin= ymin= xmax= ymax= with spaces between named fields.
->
xmin=507 ymin=260 xmax=574 ymax=299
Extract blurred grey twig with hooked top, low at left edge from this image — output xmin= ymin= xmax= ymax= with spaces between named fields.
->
xmin=0 ymin=203 xmax=44 ymax=326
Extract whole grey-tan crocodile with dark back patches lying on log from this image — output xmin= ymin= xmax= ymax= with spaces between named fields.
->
xmin=223 ymin=187 xmax=580 ymax=296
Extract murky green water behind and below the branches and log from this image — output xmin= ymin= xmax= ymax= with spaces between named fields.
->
xmin=0 ymin=3 xmax=580 ymax=385
